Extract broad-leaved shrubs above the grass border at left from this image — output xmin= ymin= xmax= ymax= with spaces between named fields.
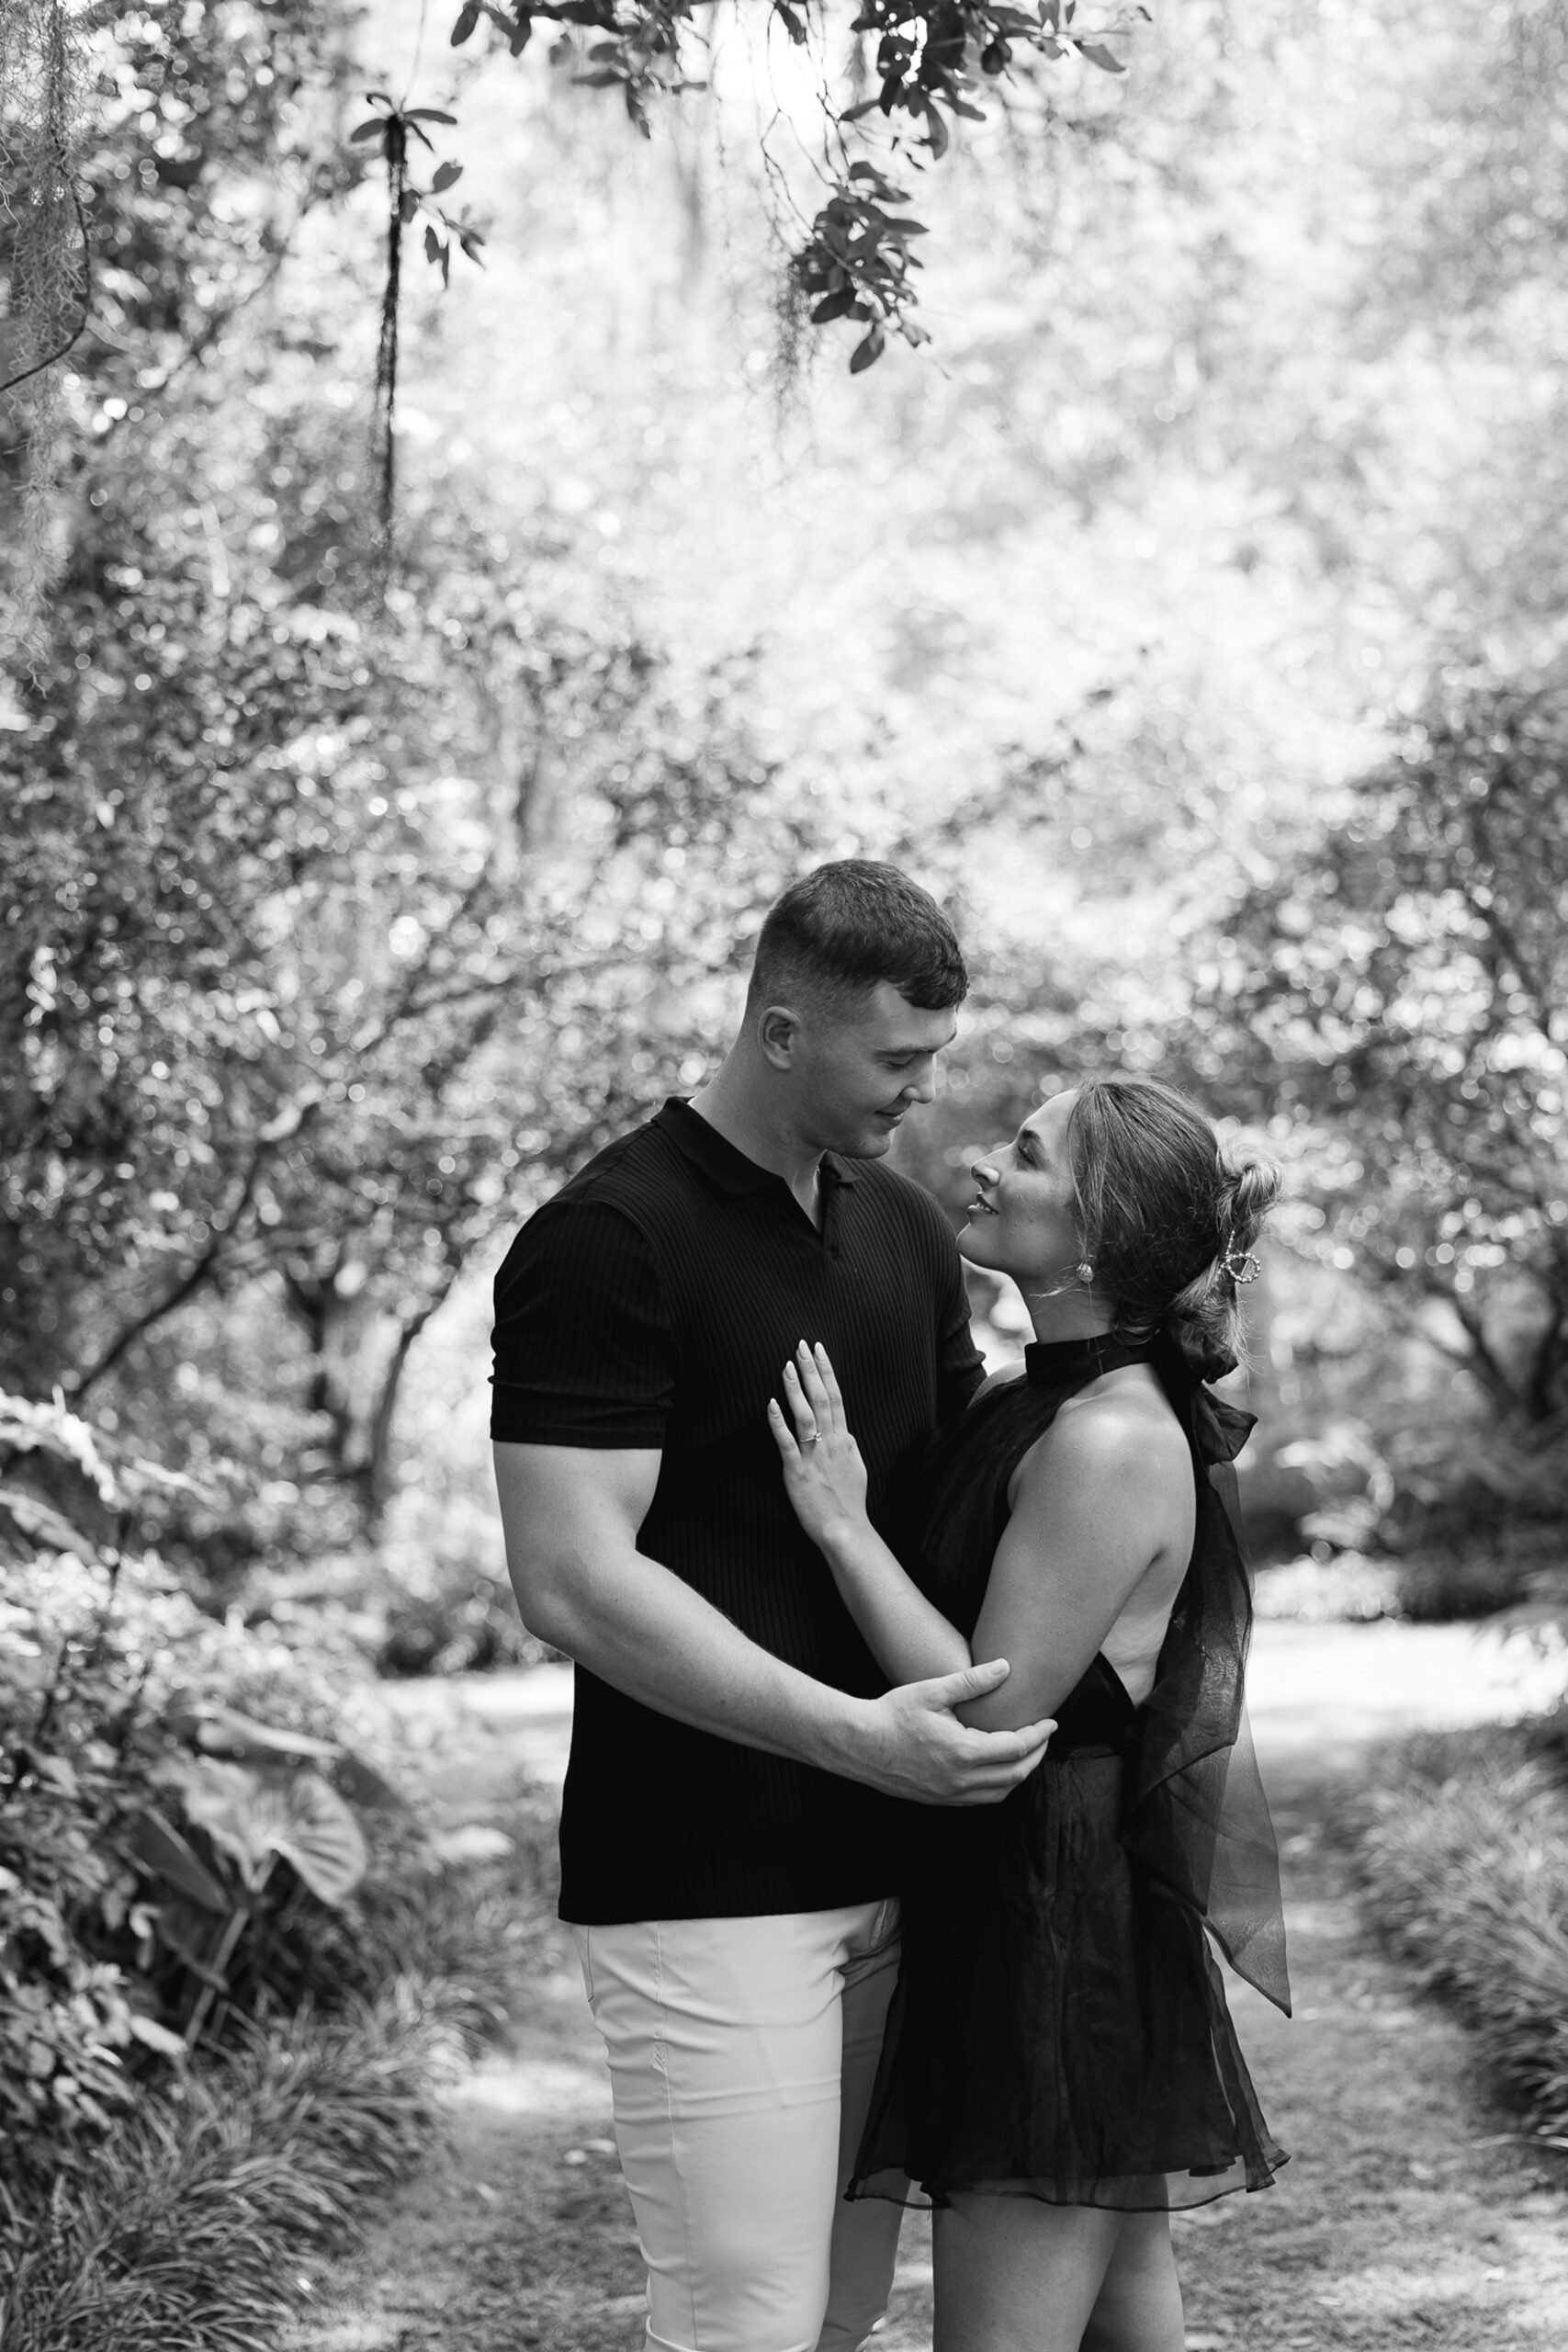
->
xmin=0 ymin=1399 xmax=460 ymax=2185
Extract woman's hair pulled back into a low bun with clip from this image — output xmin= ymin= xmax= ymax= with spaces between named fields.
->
xmin=1067 ymin=1077 xmax=1281 ymax=1381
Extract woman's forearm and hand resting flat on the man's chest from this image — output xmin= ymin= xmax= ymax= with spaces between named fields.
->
xmin=769 ymin=1340 xmax=973 ymax=1693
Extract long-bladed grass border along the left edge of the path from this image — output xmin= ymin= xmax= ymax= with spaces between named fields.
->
xmin=0 ymin=1804 xmax=564 ymax=2352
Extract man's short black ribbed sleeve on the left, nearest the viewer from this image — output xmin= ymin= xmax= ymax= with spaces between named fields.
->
xmin=489 ymin=1200 xmax=674 ymax=1446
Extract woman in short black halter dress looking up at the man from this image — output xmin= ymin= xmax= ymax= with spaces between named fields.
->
xmin=771 ymin=1080 xmax=1288 ymax=2352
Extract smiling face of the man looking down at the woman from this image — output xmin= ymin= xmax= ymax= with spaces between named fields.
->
xmin=790 ymin=981 xmax=959 ymax=1159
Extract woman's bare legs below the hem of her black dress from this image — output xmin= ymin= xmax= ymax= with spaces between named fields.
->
xmin=933 ymin=2194 xmax=1182 ymax=2352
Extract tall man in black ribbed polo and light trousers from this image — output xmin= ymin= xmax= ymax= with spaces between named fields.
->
xmin=491 ymin=858 xmax=1051 ymax=2352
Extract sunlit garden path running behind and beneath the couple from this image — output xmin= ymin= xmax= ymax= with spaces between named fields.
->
xmin=287 ymin=1625 xmax=1568 ymax=2352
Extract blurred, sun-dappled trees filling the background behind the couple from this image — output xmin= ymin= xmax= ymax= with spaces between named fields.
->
xmin=0 ymin=0 xmax=1568 ymax=1663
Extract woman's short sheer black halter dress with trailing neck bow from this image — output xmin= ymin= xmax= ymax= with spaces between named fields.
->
xmin=849 ymin=1339 xmax=1291 ymax=2211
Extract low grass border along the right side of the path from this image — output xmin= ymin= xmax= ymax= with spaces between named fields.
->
xmin=1349 ymin=1724 xmax=1568 ymax=2147
